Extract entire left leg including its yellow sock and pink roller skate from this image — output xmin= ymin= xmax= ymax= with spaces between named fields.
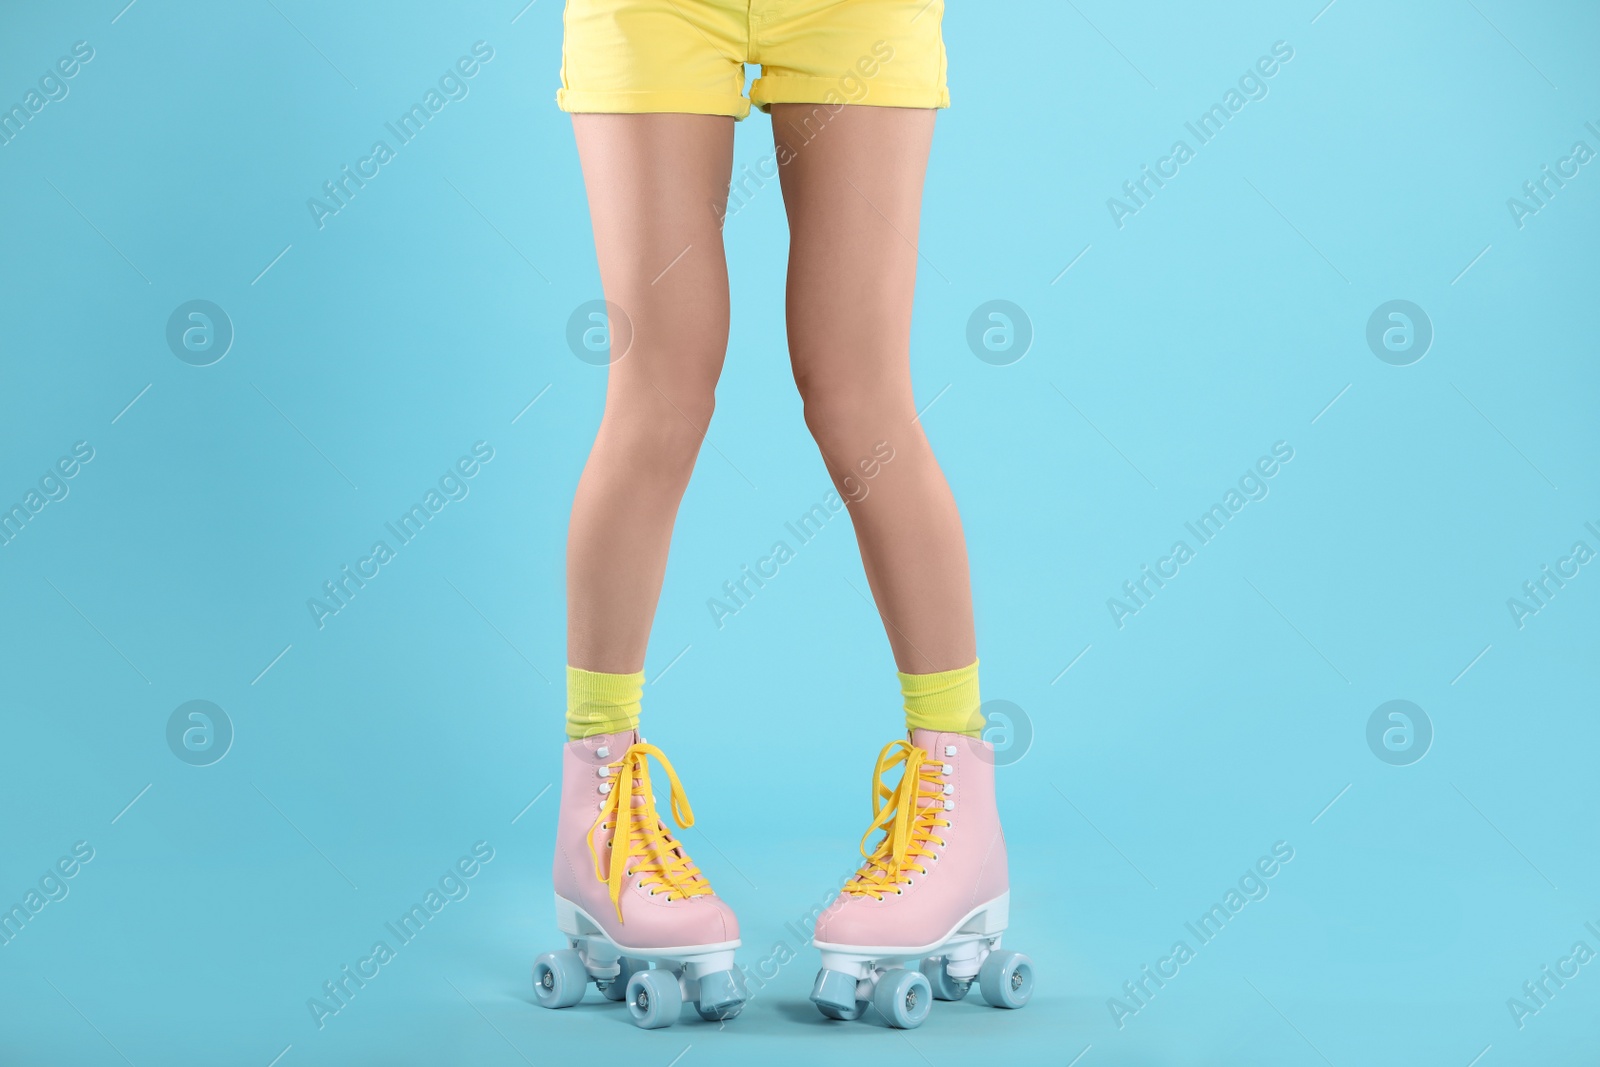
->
xmin=534 ymin=114 xmax=746 ymax=1025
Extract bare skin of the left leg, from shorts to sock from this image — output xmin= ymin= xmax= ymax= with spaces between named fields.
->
xmin=566 ymin=115 xmax=733 ymax=673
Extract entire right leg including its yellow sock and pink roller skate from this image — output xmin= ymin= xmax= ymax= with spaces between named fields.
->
xmin=773 ymin=104 xmax=1032 ymax=1025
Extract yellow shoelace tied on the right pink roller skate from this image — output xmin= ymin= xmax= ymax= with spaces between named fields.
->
xmin=845 ymin=741 xmax=950 ymax=901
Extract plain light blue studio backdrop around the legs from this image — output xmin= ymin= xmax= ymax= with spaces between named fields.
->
xmin=0 ymin=0 xmax=1600 ymax=1067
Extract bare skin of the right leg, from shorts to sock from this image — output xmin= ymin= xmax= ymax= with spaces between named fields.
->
xmin=771 ymin=104 xmax=978 ymax=673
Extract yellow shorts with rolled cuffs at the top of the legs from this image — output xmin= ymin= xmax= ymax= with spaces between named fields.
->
xmin=555 ymin=0 xmax=950 ymax=118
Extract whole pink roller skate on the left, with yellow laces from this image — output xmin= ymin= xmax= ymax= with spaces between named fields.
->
xmin=533 ymin=731 xmax=746 ymax=1029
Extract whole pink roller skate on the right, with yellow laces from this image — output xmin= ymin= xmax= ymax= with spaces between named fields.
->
xmin=811 ymin=729 xmax=1034 ymax=1029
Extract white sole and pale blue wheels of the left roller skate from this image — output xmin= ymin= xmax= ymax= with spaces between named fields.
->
xmin=533 ymin=894 xmax=747 ymax=1030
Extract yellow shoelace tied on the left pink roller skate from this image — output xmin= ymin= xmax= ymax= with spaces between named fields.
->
xmin=589 ymin=742 xmax=710 ymax=923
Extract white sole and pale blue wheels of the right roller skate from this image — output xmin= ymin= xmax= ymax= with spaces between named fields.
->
xmin=811 ymin=893 xmax=1034 ymax=1030
